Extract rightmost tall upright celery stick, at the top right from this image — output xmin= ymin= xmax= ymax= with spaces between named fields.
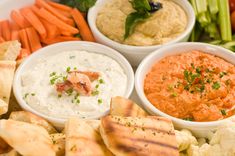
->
xmin=218 ymin=0 xmax=232 ymax=41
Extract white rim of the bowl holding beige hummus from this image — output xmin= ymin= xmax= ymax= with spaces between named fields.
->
xmin=87 ymin=0 xmax=196 ymax=53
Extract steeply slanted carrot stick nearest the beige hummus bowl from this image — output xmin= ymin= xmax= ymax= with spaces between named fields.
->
xmin=71 ymin=8 xmax=95 ymax=42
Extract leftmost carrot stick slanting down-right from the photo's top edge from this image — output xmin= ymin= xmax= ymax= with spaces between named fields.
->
xmin=35 ymin=0 xmax=70 ymax=23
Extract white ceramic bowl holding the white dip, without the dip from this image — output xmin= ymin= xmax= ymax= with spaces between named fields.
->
xmin=13 ymin=41 xmax=134 ymax=128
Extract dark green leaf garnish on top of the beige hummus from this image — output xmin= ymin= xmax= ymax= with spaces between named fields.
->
xmin=124 ymin=0 xmax=162 ymax=39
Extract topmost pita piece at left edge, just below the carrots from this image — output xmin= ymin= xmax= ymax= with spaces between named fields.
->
xmin=0 ymin=40 xmax=21 ymax=61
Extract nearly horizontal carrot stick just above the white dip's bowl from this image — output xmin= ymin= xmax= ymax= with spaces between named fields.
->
xmin=41 ymin=36 xmax=81 ymax=45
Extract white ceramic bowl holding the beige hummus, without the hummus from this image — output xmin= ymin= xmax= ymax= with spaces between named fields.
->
xmin=88 ymin=0 xmax=195 ymax=66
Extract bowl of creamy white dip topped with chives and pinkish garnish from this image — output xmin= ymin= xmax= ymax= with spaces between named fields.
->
xmin=13 ymin=41 xmax=134 ymax=127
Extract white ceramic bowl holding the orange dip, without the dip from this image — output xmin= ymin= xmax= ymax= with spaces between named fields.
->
xmin=135 ymin=42 xmax=235 ymax=137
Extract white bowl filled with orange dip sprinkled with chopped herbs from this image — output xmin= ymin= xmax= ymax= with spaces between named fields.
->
xmin=135 ymin=43 xmax=235 ymax=137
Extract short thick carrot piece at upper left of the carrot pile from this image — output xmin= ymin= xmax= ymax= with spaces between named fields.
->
xmin=11 ymin=10 xmax=31 ymax=29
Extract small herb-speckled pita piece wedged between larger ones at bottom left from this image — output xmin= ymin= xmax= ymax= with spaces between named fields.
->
xmin=50 ymin=133 xmax=65 ymax=156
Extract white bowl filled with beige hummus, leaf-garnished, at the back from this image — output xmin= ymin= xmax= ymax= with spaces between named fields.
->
xmin=88 ymin=0 xmax=195 ymax=66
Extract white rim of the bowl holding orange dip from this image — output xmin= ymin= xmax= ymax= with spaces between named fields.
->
xmin=135 ymin=42 xmax=235 ymax=127
